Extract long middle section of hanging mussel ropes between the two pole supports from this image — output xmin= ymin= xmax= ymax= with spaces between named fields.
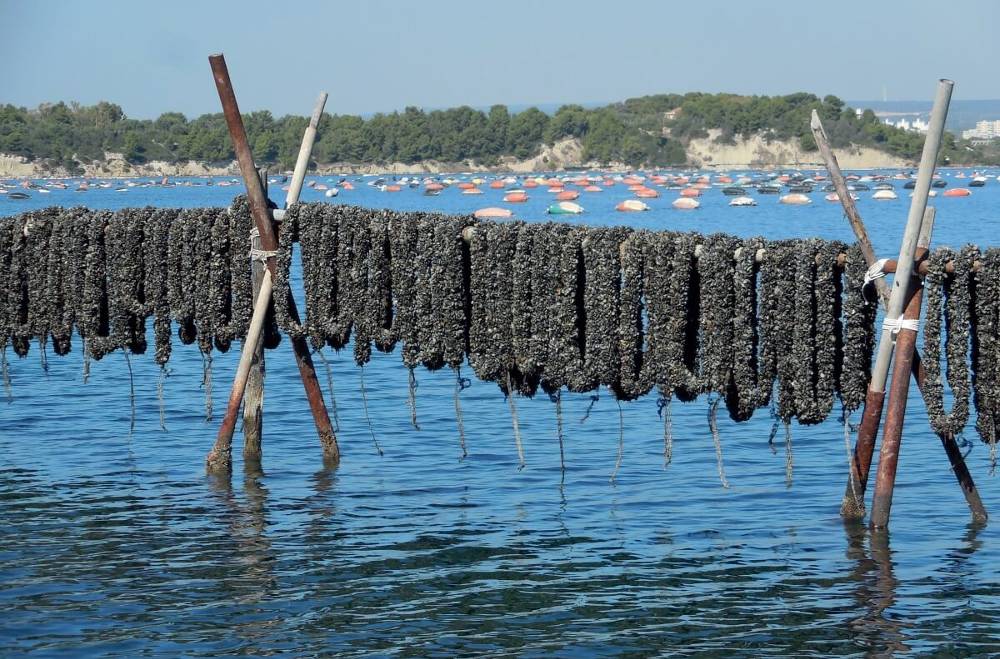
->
xmin=275 ymin=209 xmax=875 ymax=424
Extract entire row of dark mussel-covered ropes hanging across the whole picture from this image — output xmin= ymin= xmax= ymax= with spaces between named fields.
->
xmin=0 ymin=198 xmax=1000 ymax=450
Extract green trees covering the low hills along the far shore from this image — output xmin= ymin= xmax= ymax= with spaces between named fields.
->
xmin=0 ymin=93 xmax=995 ymax=172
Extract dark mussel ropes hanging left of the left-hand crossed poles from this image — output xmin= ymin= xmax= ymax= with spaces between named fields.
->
xmin=0 ymin=199 xmax=251 ymax=408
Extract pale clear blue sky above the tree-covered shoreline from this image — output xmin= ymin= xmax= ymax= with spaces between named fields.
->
xmin=0 ymin=0 xmax=1000 ymax=118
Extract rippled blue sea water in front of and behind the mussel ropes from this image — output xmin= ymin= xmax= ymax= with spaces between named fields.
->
xmin=0 ymin=170 xmax=1000 ymax=657
